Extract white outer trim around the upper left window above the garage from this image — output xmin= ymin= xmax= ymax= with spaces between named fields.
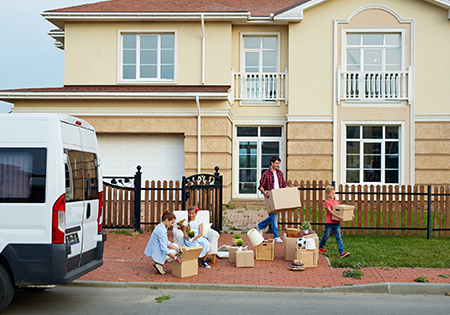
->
xmin=117 ymin=30 xmax=178 ymax=85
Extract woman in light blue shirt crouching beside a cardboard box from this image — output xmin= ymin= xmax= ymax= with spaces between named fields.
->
xmin=144 ymin=211 xmax=183 ymax=275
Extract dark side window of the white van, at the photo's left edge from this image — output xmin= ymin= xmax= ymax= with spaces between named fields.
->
xmin=0 ymin=148 xmax=47 ymax=203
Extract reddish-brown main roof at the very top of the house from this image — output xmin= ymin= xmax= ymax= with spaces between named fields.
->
xmin=44 ymin=0 xmax=312 ymax=16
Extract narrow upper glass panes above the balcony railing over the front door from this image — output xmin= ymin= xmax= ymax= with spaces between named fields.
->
xmin=244 ymin=36 xmax=278 ymax=73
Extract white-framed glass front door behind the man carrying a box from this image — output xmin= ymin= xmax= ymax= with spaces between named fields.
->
xmin=236 ymin=127 xmax=284 ymax=198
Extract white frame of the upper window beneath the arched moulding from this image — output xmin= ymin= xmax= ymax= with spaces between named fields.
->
xmin=341 ymin=27 xmax=407 ymax=72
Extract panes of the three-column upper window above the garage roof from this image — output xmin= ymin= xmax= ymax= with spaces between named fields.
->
xmin=121 ymin=33 xmax=175 ymax=81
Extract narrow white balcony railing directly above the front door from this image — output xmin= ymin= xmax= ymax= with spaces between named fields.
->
xmin=234 ymin=69 xmax=288 ymax=104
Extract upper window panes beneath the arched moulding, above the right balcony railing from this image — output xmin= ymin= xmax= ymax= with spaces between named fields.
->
xmin=346 ymin=33 xmax=402 ymax=71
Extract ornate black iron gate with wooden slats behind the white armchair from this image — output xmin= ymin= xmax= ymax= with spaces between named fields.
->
xmin=182 ymin=166 xmax=223 ymax=232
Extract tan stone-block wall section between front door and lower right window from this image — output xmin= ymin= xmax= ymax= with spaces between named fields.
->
xmin=287 ymin=122 xmax=333 ymax=181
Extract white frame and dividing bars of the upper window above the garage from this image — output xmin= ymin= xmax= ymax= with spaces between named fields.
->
xmin=117 ymin=30 xmax=178 ymax=84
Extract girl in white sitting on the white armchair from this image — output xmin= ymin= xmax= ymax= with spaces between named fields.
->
xmin=183 ymin=206 xmax=211 ymax=269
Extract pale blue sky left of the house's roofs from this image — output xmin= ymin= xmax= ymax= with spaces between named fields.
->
xmin=0 ymin=0 xmax=100 ymax=113
